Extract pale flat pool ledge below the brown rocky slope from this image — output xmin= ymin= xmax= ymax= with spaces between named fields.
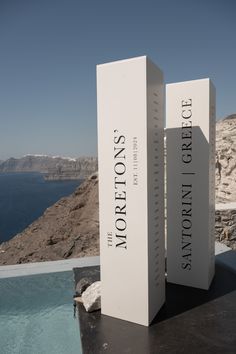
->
xmin=0 ymin=257 xmax=100 ymax=278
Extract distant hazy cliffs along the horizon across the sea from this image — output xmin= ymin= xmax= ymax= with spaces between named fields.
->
xmin=0 ymin=155 xmax=98 ymax=180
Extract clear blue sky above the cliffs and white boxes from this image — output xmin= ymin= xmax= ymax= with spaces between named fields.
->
xmin=0 ymin=0 xmax=236 ymax=160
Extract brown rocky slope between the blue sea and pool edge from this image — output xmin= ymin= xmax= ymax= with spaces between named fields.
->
xmin=0 ymin=174 xmax=99 ymax=265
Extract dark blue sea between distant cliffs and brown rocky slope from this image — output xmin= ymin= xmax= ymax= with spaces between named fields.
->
xmin=0 ymin=172 xmax=82 ymax=244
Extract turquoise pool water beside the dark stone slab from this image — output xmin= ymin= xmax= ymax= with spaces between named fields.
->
xmin=0 ymin=272 xmax=82 ymax=354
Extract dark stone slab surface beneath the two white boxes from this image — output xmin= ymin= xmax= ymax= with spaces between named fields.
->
xmin=74 ymin=263 xmax=236 ymax=354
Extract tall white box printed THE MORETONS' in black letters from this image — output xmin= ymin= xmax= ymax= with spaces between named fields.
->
xmin=97 ymin=56 xmax=165 ymax=326
